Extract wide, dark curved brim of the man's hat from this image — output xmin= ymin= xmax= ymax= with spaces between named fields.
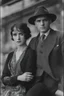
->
xmin=28 ymin=14 xmax=57 ymax=25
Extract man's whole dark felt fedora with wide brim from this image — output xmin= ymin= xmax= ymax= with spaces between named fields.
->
xmin=28 ymin=6 xmax=56 ymax=25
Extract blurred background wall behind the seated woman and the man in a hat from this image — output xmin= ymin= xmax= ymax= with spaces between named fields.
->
xmin=0 ymin=0 xmax=64 ymax=93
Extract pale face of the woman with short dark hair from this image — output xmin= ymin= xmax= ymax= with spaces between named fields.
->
xmin=12 ymin=30 xmax=26 ymax=46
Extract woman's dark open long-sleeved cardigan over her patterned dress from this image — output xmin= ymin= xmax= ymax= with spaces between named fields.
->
xmin=2 ymin=47 xmax=36 ymax=89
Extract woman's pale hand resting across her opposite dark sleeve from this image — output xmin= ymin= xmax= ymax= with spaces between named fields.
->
xmin=17 ymin=72 xmax=33 ymax=82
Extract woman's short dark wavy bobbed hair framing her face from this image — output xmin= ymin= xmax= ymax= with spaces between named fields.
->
xmin=11 ymin=23 xmax=31 ymax=40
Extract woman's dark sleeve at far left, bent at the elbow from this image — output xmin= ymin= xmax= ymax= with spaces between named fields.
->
xmin=1 ymin=53 xmax=18 ymax=86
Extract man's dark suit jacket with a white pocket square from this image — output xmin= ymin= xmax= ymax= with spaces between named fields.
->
xmin=29 ymin=29 xmax=62 ymax=91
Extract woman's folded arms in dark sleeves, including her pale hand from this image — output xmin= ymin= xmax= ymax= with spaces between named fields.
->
xmin=2 ymin=50 xmax=36 ymax=86
